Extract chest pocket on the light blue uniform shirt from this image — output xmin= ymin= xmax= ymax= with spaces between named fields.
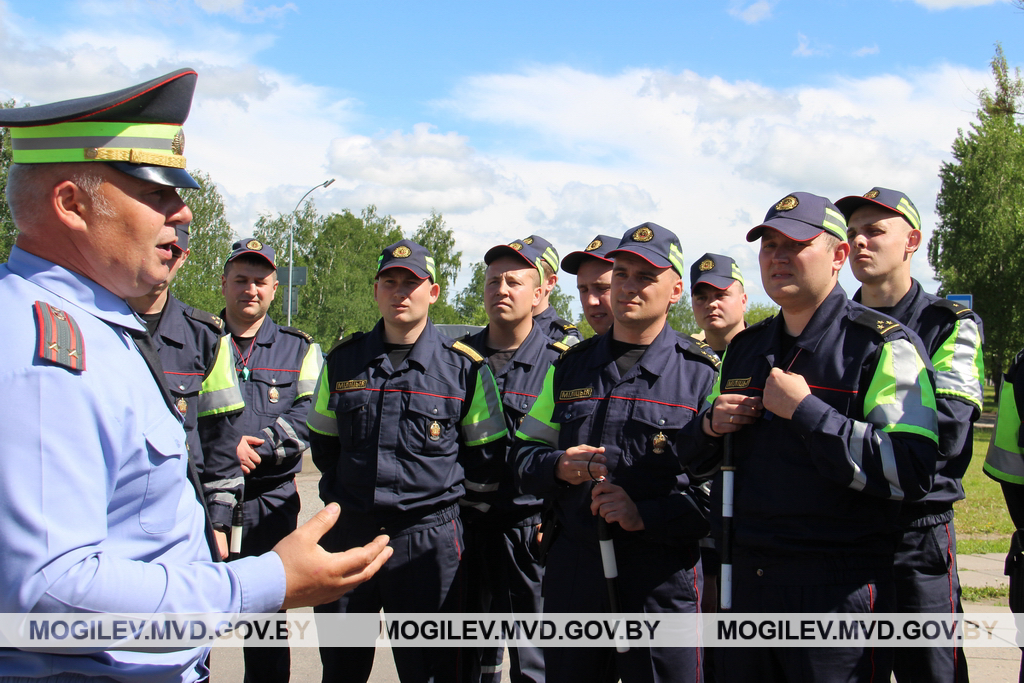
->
xmin=138 ymin=413 xmax=190 ymax=533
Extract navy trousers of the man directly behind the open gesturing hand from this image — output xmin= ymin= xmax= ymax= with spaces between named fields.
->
xmin=313 ymin=505 xmax=464 ymax=683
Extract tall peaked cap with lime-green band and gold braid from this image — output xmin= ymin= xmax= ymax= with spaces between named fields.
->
xmin=0 ymin=69 xmax=199 ymax=189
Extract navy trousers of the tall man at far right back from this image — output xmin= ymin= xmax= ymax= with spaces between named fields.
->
xmin=893 ymin=521 xmax=969 ymax=683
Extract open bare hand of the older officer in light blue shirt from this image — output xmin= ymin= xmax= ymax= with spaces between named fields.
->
xmin=273 ymin=503 xmax=394 ymax=609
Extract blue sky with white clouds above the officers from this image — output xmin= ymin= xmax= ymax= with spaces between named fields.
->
xmin=0 ymin=0 xmax=1024 ymax=299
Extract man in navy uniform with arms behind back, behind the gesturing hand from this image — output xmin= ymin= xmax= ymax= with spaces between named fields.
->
xmin=309 ymin=240 xmax=508 ymax=682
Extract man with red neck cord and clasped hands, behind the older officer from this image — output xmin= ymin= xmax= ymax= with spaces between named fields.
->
xmin=220 ymin=238 xmax=324 ymax=683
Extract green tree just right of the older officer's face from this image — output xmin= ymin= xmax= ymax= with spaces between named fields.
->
xmin=171 ymin=169 xmax=234 ymax=313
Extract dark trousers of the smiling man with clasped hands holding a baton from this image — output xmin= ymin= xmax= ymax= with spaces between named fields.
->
xmin=544 ymin=525 xmax=703 ymax=683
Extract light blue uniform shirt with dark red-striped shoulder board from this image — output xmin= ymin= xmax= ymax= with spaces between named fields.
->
xmin=0 ymin=247 xmax=285 ymax=681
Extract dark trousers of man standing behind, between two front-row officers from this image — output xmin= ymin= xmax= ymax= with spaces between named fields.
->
xmin=463 ymin=519 xmax=544 ymax=683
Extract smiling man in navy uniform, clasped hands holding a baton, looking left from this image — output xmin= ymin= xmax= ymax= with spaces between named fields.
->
xmin=513 ymin=223 xmax=718 ymax=683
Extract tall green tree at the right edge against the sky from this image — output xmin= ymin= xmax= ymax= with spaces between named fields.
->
xmin=928 ymin=45 xmax=1024 ymax=380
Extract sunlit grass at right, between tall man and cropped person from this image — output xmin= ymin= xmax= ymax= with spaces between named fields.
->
xmin=953 ymin=428 xmax=1014 ymax=553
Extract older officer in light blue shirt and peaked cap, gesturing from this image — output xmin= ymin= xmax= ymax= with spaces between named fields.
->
xmin=0 ymin=69 xmax=391 ymax=682
